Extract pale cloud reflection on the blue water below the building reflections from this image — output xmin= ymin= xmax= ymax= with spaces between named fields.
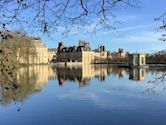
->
xmin=59 ymin=89 xmax=145 ymax=109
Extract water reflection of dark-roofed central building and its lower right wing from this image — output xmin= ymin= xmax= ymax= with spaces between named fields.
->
xmin=55 ymin=65 xmax=128 ymax=88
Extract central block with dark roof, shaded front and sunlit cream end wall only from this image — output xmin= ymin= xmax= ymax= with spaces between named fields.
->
xmin=57 ymin=41 xmax=94 ymax=64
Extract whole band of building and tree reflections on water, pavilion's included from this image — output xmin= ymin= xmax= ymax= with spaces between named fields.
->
xmin=0 ymin=65 xmax=146 ymax=105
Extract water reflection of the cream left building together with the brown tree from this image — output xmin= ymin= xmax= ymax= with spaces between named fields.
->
xmin=0 ymin=65 xmax=56 ymax=105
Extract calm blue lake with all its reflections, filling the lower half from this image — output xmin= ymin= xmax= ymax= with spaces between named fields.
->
xmin=0 ymin=65 xmax=166 ymax=125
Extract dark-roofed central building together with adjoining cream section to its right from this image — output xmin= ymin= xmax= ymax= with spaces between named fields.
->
xmin=57 ymin=40 xmax=110 ymax=64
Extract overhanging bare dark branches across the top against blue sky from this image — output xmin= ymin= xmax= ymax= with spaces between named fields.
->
xmin=0 ymin=0 xmax=139 ymax=33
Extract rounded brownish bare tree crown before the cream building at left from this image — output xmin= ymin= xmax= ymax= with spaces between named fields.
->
xmin=0 ymin=31 xmax=36 ymax=65
